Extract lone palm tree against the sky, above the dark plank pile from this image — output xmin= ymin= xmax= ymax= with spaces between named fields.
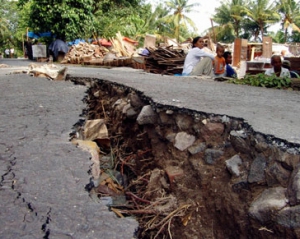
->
xmin=161 ymin=0 xmax=200 ymax=42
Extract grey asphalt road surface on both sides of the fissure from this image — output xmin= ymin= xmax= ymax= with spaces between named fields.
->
xmin=0 ymin=59 xmax=300 ymax=239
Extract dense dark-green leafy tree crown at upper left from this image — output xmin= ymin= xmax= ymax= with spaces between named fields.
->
xmin=19 ymin=0 xmax=94 ymax=40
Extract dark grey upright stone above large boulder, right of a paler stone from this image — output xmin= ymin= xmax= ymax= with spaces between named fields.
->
xmin=248 ymin=155 xmax=267 ymax=183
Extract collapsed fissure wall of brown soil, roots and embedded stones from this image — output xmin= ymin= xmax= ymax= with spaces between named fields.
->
xmin=68 ymin=77 xmax=300 ymax=238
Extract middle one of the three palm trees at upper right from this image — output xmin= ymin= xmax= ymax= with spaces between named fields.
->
xmin=243 ymin=0 xmax=280 ymax=40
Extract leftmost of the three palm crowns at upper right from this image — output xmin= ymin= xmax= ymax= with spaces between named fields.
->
xmin=213 ymin=0 xmax=245 ymax=38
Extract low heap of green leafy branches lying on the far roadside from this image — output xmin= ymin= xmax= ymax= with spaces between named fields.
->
xmin=228 ymin=73 xmax=291 ymax=89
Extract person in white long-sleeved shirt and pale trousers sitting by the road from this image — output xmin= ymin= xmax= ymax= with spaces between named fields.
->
xmin=182 ymin=36 xmax=215 ymax=77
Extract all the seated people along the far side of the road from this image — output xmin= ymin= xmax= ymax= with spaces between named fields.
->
xmin=182 ymin=36 xmax=299 ymax=78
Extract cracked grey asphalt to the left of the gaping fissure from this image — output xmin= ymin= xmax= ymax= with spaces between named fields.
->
xmin=0 ymin=58 xmax=138 ymax=239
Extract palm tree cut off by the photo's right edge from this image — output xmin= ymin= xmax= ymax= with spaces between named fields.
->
xmin=277 ymin=0 xmax=300 ymax=42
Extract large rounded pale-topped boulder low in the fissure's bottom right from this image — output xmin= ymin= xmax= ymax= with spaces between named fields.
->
xmin=249 ymin=187 xmax=288 ymax=223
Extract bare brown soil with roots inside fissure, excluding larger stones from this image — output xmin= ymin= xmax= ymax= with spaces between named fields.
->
xmin=69 ymin=77 xmax=298 ymax=239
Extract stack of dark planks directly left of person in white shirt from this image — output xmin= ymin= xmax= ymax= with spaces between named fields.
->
xmin=145 ymin=46 xmax=186 ymax=75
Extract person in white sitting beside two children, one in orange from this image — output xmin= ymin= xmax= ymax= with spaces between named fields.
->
xmin=182 ymin=36 xmax=236 ymax=78
